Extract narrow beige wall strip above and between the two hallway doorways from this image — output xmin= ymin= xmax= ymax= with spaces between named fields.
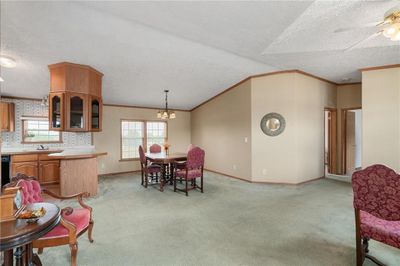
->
xmin=337 ymin=84 xmax=361 ymax=174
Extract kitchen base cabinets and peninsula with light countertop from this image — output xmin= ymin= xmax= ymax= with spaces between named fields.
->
xmin=2 ymin=149 xmax=107 ymax=196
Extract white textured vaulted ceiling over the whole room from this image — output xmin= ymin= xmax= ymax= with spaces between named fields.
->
xmin=1 ymin=0 xmax=400 ymax=109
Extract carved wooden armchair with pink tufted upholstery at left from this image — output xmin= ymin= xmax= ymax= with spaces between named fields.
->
xmin=5 ymin=174 xmax=94 ymax=266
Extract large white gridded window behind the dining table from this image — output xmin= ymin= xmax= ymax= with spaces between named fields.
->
xmin=121 ymin=120 xmax=167 ymax=160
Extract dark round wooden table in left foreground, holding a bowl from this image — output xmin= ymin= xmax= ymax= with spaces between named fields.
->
xmin=0 ymin=202 xmax=61 ymax=266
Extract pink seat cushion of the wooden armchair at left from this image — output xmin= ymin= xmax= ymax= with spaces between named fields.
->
xmin=40 ymin=208 xmax=90 ymax=239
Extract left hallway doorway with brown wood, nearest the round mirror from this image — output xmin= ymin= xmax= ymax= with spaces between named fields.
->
xmin=324 ymin=108 xmax=337 ymax=175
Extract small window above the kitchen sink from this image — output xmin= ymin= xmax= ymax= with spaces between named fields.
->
xmin=22 ymin=117 xmax=61 ymax=143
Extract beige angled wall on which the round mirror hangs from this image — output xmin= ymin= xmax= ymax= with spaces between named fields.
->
xmin=251 ymin=73 xmax=336 ymax=183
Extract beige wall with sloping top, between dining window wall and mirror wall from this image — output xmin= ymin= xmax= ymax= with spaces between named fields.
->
xmin=191 ymin=80 xmax=251 ymax=180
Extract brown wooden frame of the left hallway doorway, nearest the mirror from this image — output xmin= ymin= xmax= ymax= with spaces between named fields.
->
xmin=324 ymin=107 xmax=338 ymax=174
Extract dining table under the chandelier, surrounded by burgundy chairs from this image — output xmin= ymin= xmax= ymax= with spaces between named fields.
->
xmin=145 ymin=152 xmax=187 ymax=191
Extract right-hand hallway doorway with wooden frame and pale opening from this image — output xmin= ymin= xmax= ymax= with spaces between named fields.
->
xmin=341 ymin=108 xmax=362 ymax=176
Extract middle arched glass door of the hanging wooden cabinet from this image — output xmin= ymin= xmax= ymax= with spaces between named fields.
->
xmin=65 ymin=93 xmax=89 ymax=131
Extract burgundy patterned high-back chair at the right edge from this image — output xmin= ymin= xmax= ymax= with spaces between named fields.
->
xmin=352 ymin=164 xmax=400 ymax=266
